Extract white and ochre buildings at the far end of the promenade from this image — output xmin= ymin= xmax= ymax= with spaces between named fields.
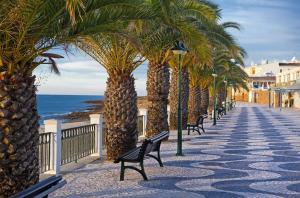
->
xmin=235 ymin=58 xmax=300 ymax=107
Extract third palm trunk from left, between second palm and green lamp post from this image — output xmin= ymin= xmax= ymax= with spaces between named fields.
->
xmin=146 ymin=61 xmax=170 ymax=137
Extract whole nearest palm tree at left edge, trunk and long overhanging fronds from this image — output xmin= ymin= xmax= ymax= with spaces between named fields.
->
xmin=0 ymin=0 xmax=150 ymax=197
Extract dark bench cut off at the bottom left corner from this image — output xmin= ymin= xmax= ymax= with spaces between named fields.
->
xmin=11 ymin=175 xmax=66 ymax=198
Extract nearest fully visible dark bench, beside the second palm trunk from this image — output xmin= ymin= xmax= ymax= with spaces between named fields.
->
xmin=115 ymin=131 xmax=169 ymax=181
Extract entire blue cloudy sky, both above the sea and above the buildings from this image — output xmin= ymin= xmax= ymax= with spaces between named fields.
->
xmin=35 ymin=0 xmax=300 ymax=95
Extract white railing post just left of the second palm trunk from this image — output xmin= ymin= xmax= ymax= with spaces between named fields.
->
xmin=90 ymin=114 xmax=103 ymax=158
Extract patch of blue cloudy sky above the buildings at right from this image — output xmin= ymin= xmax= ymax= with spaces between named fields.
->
xmin=214 ymin=0 xmax=300 ymax=64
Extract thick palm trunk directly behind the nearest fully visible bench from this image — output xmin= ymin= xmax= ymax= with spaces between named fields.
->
xmin=104 ymin=73 xmax=138 ymax=160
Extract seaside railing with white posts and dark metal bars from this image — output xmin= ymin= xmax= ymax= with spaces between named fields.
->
xmin=39 ymin=109 xmax=147 ymax=174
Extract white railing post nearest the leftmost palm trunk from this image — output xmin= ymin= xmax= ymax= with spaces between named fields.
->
xmin=44 ymin=120 xmax=61 ymax=175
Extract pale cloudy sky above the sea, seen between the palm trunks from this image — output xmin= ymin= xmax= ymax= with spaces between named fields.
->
xmin=34 ymin=60 xmax=147 ymax=95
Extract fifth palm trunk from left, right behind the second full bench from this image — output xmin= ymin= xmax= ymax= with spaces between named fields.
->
xmin=188 ymin=86 xmax=201 ymax=123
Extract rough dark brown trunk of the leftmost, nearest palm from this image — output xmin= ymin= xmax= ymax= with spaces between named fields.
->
xmin=0 ymin=72 xmax=39 ymax=197
